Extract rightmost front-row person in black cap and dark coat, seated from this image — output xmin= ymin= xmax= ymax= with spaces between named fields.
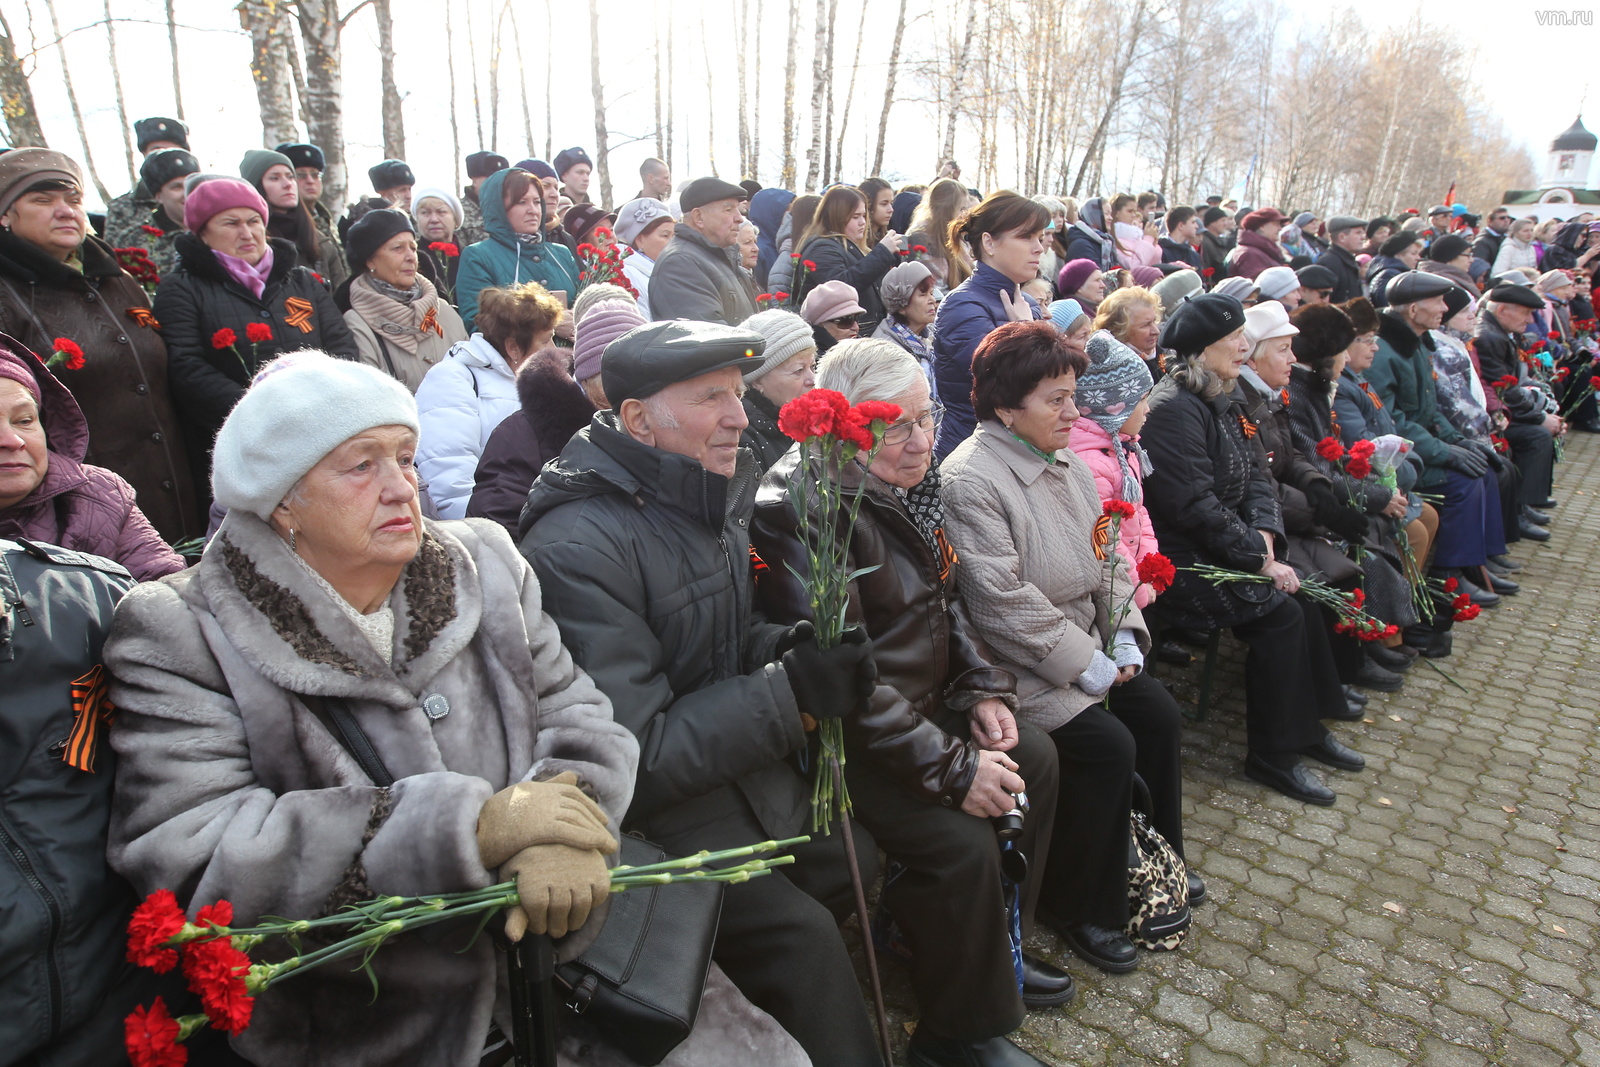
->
xmin=1474 ymin=285 xmax=1566 ymax=541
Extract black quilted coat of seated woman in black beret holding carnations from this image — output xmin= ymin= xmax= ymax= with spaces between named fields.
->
xmin=1139 ymin=378 xmax=1286 ymax=629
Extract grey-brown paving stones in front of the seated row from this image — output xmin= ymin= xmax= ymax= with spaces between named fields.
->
xmin=864 ymin=435 xmax=1600 ymax=1067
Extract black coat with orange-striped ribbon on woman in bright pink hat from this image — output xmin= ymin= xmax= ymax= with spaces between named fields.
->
xmin=155 ymin=234 xmax=357 ymax=499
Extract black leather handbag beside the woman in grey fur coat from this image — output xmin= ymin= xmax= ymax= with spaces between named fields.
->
xmin=301 ymin=696 xmax=725 ymax=1067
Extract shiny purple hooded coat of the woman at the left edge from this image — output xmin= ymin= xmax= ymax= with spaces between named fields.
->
xmin=0 ymin=334 xmax=186 ymax=582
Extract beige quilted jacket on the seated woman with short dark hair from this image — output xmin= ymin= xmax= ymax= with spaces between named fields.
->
xmin=939 ymin=419 xmax=1150 ymax=731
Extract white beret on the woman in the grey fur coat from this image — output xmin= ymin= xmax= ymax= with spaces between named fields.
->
xmin=211 ymin=349 xmax=419 ymax=522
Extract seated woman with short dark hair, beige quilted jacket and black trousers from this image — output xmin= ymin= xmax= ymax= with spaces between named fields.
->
xmin=941 ymin=322 xmax=1205 ymax=974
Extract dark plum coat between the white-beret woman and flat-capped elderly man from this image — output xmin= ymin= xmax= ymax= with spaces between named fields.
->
xmin=467 ymin=355 xmax=595 ymax=534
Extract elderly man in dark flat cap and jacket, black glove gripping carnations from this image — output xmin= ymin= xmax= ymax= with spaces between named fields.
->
xmin=518 ymin=316 xmax=880 ymax=1067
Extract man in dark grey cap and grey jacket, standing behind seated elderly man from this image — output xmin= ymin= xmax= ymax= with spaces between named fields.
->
xmin=650 ymin=178 xmax=755 ymax=325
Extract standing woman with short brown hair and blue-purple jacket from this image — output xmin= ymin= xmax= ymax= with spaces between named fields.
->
xmin=933 ymin=192 xmax=1050 ymax=456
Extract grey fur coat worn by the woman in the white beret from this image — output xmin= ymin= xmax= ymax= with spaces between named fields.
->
xmin=96 ymin=510 xmax=638 ymax=1067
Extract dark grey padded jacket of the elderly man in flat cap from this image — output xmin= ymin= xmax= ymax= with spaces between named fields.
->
xmin=518 ymin=411 xmax=811 ymax=838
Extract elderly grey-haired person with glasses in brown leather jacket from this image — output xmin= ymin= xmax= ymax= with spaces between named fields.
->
xmin=750 ymin=339 xmax=1075 ymax=1064
